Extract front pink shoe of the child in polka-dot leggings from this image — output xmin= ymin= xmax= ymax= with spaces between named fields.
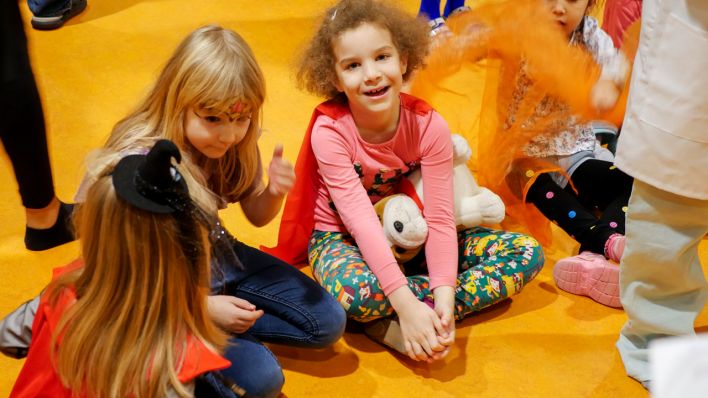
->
xmin=553 ymin=251 xmax=622 ymax=308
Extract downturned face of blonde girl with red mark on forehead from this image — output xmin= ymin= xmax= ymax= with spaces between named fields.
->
xmin=184 ymin=107 xmax=251 ymax=159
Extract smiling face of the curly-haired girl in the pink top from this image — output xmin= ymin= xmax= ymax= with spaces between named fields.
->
xmin=332 ymin=23 xmax=406 ymax=113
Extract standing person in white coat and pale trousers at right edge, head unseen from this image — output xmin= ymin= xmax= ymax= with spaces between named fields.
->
xmin=615 ymin=0 xmax=708 ymax=387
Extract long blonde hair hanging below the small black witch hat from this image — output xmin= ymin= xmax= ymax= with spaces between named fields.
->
xmin=48 ymin=176 xmax=226 ymax=398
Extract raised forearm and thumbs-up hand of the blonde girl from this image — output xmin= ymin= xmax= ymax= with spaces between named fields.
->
xmin=240 ymin=145 xmax=295 ymax=227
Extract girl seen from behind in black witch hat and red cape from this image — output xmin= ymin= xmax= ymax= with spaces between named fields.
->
xmin=0 ymin=140 xmax=238 ymax=397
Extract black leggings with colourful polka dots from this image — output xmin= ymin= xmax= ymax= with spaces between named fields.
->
xmin=526 ymin=159 xmax=633 ymax=254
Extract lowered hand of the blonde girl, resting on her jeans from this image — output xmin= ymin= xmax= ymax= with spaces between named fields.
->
xmin=207 ymin=296 xmax=263 ymax=334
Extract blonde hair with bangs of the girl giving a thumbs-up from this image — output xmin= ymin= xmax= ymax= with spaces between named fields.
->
xmin=95 ymin=25 xmax=265 ymax=211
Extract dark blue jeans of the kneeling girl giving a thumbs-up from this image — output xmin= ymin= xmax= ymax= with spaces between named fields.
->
xmin=212 ymin=242 xmax=346 ymax=397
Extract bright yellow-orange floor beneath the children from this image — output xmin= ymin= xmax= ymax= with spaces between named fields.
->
xmin=0 ymin=0 xmax=708 ymax=398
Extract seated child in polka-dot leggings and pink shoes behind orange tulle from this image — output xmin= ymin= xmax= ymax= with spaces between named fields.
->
xmin=507 ymin=0 xmax=632 ymax=307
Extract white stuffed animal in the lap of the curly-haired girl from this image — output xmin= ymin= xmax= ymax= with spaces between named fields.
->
xmin=374 ymin=134 xmax=505 ymax=263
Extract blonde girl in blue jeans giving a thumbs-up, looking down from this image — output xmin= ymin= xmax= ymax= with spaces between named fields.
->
xmin=83 ymin=26 xmax=346 ymax=396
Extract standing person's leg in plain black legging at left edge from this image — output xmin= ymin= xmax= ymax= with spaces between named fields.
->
xmin=0 ymin=0 xmax=54 ymax=209
